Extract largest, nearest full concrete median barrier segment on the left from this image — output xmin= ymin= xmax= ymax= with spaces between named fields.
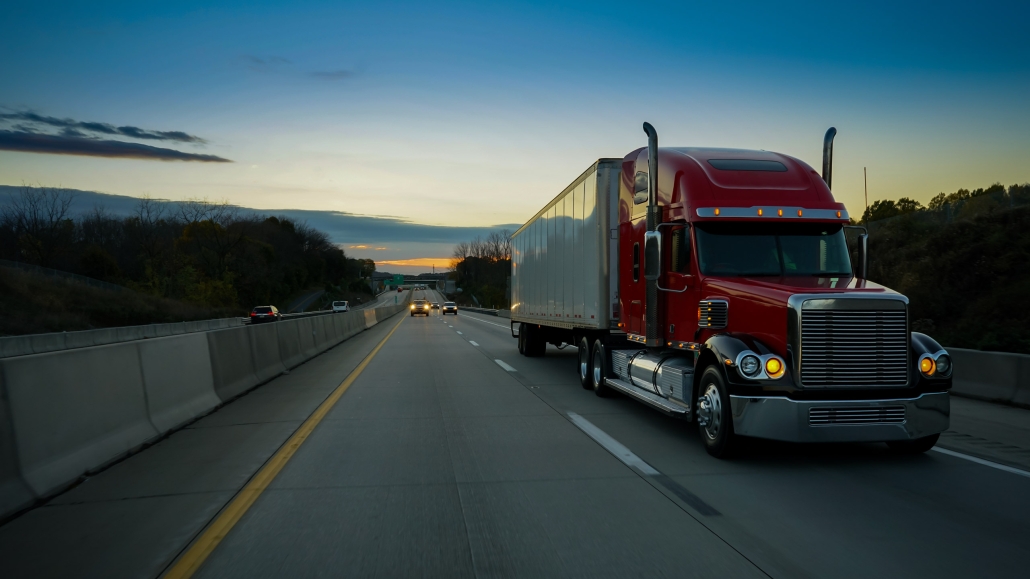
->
xmin=0 ymin=343 xmax=158 ymax=497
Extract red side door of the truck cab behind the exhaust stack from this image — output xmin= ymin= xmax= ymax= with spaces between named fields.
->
xmin=658 ymin=224 xmax=700 ymax=345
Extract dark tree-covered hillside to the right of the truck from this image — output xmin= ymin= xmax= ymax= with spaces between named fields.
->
xmin=864 ymin=184 xmax=1030 ymax=353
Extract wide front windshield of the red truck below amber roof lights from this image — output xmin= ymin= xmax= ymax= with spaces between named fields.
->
xmin=696 ymin=223 xmax=852 ymax=277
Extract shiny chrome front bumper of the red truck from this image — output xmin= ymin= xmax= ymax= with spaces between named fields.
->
xmin=729 ymin=393 xmax=951 ymax=442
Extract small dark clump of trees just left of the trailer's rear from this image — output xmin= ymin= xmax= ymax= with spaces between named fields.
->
xmin=451 ymin=230 xmax=512 ymax=308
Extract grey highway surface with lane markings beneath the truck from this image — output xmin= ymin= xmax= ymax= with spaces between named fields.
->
xmin=0 ymin=291 xmax=1030 ymax=578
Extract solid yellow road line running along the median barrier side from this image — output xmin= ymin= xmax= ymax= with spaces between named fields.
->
xmin=164 ymin=315 xmax=408 ymax=579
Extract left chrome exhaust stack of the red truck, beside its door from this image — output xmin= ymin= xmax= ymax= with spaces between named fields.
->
xmin=644 ymin=123 xmax=664 ymax=348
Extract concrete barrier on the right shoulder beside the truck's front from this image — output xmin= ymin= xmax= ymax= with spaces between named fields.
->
xmin=946 ymin=348 xmax=1030 ymax=407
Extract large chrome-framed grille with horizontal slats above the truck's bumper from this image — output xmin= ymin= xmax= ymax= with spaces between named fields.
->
xmin=800 ymin=309 xmax=908 ymax=387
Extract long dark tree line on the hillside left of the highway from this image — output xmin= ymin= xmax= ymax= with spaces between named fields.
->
xmin=0 ymin=186 xmax=375 ymax=309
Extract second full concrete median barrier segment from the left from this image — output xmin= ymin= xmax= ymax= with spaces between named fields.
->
xmin=137 ymin=334 xmax=221 ymax=434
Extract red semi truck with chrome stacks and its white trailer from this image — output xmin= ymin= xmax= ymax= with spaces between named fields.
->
xmin=511 ymin=124 xmax=952 ymax=456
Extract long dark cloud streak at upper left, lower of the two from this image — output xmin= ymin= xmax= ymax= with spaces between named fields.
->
xmin=0 ymin=128 xmax=232 ymax=163
